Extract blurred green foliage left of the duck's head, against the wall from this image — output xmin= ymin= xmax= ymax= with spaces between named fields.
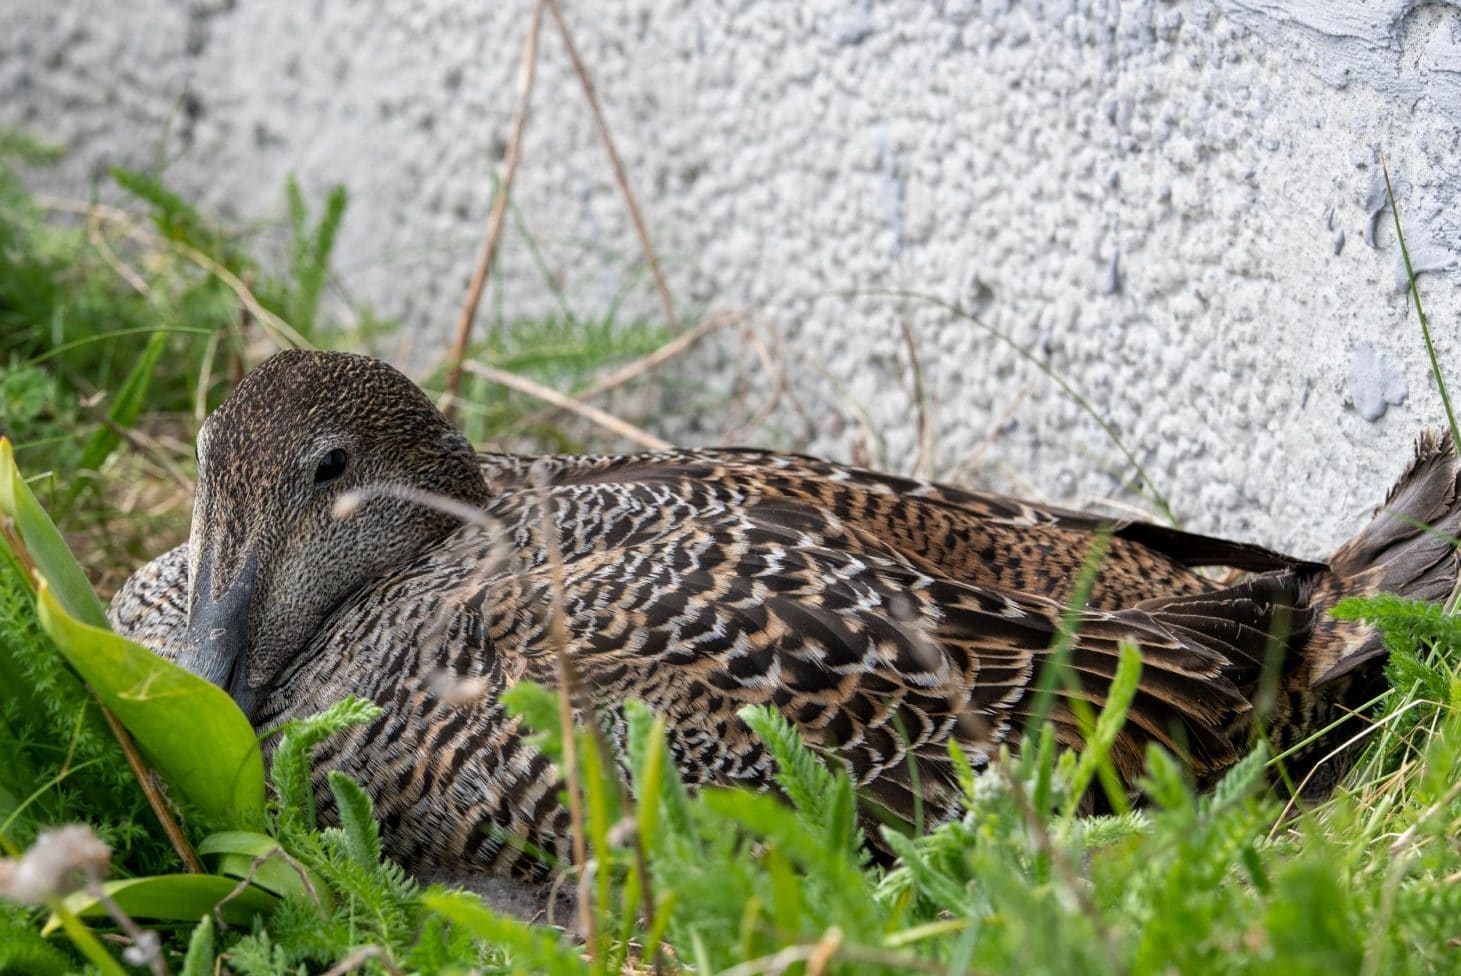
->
xmin=0 ymin=138 xmax=365 ymax=537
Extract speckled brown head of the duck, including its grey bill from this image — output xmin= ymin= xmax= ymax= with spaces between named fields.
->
xmin=178 ymin=351 xmax=487 ymax=719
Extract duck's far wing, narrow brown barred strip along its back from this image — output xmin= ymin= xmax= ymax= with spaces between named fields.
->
xmin=481 ymin=449 xmax=1313 ymax=609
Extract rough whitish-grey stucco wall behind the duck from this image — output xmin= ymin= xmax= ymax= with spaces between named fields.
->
xmin=0 ymin=0 xmax=1461 ymax=554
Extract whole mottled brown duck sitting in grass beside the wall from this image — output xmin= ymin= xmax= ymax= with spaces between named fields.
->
xmin=111 ymin=352 xmax=1461 ymax=875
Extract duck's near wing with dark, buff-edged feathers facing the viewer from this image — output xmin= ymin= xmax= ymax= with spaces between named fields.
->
xmin=479 ymin=476 xmax=1306 ymax=818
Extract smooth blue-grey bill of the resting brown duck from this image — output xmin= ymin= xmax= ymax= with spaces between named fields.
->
xmin=177 ymin=554 xmax=259 ymax=722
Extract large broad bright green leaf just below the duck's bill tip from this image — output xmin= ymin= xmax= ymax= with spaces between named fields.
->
xmin=37 ymin=580 xmax=264 ymax=829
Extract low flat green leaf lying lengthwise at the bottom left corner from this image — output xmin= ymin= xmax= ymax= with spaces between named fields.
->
xmin=41 ymin=874 xmax=279 ymax=935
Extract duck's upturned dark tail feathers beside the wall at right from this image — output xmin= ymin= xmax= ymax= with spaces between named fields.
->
xmin=1308 ymin=431 xmax=1461 ymax=687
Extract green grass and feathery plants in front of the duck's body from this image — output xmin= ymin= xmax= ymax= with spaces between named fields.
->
xmin=0 ymin=552 xmax=1461 ymax=973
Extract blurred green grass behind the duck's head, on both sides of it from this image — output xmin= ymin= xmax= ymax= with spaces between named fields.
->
xmin=0 ymin=129 xmax=666 ymax=592
